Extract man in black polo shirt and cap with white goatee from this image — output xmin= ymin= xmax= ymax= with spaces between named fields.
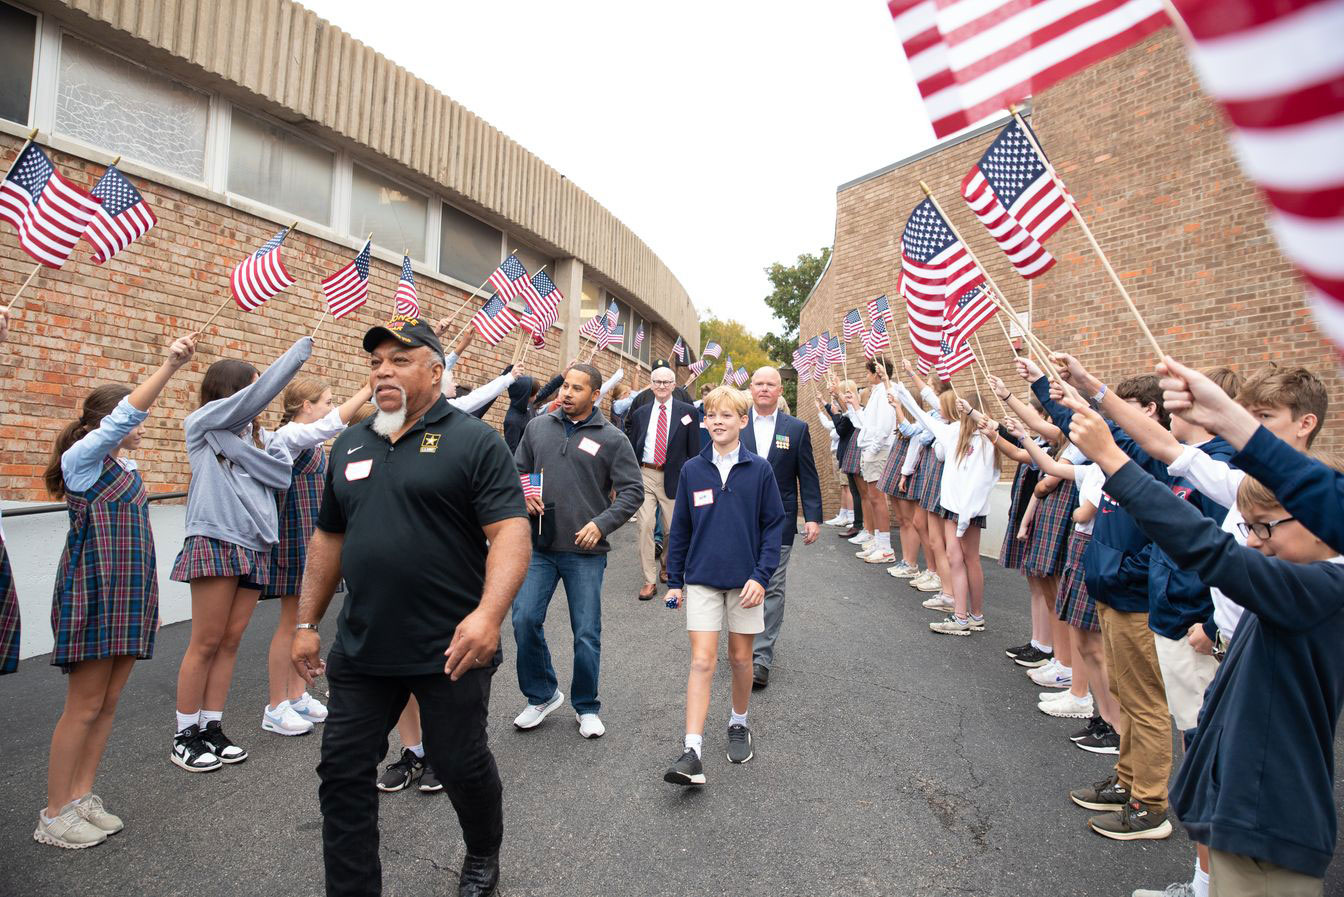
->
xmin=292 ymin=317 xmax=531 ymax=897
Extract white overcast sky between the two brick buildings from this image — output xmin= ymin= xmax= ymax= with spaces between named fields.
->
xmin=301 ymin=0 xmax=933 ymax=334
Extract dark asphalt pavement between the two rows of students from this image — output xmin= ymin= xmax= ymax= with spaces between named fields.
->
xmin=0 ymin=526 xmax=1344 ymax=897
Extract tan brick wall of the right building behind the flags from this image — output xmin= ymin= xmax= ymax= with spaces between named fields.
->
xmin=800 ymin=30 xmax=1344 ymax=515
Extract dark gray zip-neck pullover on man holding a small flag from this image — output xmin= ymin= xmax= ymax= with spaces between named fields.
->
xmin=513 ymin=409 xmax=644 ymax=554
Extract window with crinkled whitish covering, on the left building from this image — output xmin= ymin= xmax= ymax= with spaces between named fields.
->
xmin=55 ymin=35 xmax=210 ymax=180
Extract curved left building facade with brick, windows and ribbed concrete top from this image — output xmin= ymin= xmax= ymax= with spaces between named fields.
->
xmin=0 ymin=0 xmax=699 ymax=500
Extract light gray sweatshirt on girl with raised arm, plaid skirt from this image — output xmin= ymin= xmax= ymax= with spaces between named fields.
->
xmin=183 ymin=336 xmax=313 ymax=551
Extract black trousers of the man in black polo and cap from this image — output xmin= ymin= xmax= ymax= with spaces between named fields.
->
xmin=317 ymin=652 xmax=504 ymax=897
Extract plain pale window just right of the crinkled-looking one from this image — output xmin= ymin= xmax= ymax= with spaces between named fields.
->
xmin=228 ymin=108 xmax=330 ymax=224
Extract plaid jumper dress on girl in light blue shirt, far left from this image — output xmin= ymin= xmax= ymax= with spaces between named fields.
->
xmin=51 ymin=457 xmax=159 ymax=672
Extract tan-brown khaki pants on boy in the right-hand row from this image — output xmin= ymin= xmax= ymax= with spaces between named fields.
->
xmin=1097 ymin=601 xmax=1172 ymax=812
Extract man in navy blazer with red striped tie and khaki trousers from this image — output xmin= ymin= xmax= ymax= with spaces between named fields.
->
xmin=625 ymin=362 xmax=700 ymax=601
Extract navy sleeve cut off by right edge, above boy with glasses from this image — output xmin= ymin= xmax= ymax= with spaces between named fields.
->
xmin=1232 ymin=426 xmax=1344 ymax=554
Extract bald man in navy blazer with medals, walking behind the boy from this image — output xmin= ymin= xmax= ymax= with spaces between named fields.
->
xmin=742 ymin=367 xmax=821 ymax=689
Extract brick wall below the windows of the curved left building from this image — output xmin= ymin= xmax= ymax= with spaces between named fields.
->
xmin=0 ymin=136 xmax=564 ymax=500
